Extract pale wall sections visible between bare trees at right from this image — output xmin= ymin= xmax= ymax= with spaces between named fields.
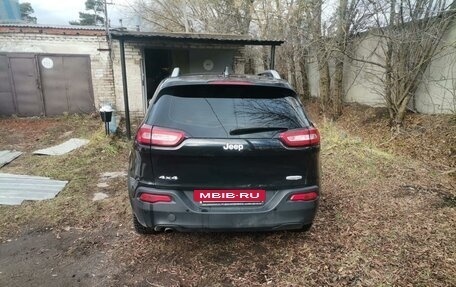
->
xmin=307 ymin=23 xmax=456 ymax=114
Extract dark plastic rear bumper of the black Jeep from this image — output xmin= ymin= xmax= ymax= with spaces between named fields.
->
xmin=130 ymin=186 xmax=318 ymax=234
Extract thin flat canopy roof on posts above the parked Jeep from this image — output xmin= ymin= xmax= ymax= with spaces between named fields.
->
xmin=111 ymin=30 xmax=284 ymax=45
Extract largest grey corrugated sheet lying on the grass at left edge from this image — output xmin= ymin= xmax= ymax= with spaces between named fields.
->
xmin=0 ymin=173 xmax=68 ymax=205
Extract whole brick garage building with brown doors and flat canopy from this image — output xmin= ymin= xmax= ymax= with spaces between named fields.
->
xmin=0 ymin=24 xmax=283 ymax=120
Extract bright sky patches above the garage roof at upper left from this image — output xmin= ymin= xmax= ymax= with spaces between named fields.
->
xmin=23 ymin=0 xmax=133 ymax=27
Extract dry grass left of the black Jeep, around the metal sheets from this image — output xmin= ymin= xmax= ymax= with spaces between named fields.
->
xmin=0 ymin=116 xmax=129 ymax=236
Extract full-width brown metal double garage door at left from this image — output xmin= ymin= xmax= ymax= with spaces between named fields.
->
xmin=0 ymin=54 xmax=95 ymax=116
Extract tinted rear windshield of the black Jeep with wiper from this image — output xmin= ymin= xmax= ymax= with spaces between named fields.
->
xmin=146 ymin=85 xmax=309 ymax=138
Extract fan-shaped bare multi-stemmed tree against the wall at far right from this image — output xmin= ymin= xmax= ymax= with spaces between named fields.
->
xmin=346 ymin=0 xmax=456 ymax=128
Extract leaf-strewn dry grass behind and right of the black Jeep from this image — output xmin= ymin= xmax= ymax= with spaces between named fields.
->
xmin=111 ymin=119 xmax=456 ymax=286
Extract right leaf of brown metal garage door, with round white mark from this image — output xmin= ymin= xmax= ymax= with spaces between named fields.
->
xmin=38 ymin=55 xmax=95 ymax=116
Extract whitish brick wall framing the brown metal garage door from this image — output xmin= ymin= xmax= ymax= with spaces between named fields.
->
xmin=0 ymin=27 xmax=115 ymax=108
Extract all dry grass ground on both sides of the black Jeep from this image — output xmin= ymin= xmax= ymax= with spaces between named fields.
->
xmin=0 ymin=111 xmax=456 ymax=286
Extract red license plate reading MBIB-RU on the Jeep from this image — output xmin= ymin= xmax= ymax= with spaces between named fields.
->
xmin=193 ymin=189 xmax=266 ymax=205
